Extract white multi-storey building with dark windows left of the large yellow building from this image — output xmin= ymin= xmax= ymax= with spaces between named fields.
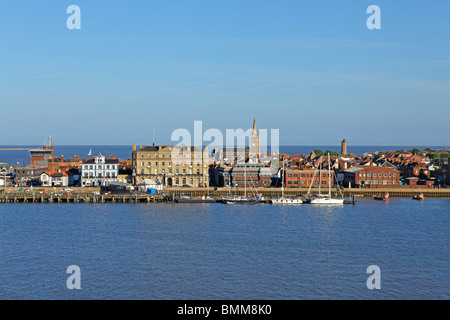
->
xmin=81 ymin=154 xmax=119 ymax=187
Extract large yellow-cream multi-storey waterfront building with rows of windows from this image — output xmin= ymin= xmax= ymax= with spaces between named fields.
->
xmin=132 ymin=143 xmax=210 ymax=187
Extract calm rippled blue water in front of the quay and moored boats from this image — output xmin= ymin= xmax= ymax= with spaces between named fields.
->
xmin=0 ymin=199 xmax=450 ymax=299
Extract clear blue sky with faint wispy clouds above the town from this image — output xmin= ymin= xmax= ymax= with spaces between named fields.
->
xmin=0 ymin=0 xmax=450 ymax=145
